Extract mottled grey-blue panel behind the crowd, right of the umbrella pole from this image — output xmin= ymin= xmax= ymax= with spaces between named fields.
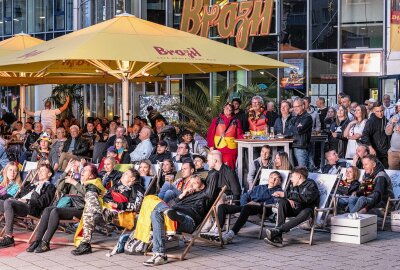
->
xmin=139 ymin=95 xmax=180 ymax=123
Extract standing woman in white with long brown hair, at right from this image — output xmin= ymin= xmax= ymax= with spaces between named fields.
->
xmin=344 ymin=105 xmax=368 ymax=159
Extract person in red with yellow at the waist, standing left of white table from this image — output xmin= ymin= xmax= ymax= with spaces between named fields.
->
xmin=207 ymin=103 xmax=243 ymax=170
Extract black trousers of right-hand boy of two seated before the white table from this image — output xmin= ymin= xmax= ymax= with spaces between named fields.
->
xmin=277 ymin=199 xmax=313 ymax=232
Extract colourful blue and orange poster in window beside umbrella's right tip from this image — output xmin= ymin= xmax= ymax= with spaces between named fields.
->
xmin=281 ymin=59 xmax=305 ymax=90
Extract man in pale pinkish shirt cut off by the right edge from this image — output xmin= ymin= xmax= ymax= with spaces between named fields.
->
xmin=385 ymin=100 xmax=400 ymax=170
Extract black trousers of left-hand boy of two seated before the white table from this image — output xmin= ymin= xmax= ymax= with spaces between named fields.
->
xmin=217 ymin=204 xmax=263 ymax=234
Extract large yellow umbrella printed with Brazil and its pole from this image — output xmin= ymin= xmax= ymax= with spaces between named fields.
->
xmin=0 ymin=14 xmax=289 ymax=124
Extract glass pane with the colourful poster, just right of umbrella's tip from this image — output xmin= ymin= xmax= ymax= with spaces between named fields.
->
xmin=280 ymin=53 xmax=307 ymax=98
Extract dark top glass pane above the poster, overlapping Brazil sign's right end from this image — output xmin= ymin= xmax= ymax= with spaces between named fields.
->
xmin=281 ymin=0 xmax=307 ymax=51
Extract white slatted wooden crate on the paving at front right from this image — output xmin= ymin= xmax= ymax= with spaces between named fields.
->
xmin=331 ymin=214 xmax=377 ymax=244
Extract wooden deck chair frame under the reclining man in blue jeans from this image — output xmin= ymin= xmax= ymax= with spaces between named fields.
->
xmin=145 ymin=186 xmax=226 ymax=261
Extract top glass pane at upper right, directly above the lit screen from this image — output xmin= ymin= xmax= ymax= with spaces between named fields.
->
xmin=341 ymin=0 xmax=385 ymax=48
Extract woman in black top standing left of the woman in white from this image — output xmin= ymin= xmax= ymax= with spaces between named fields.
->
xmin=328 ymin=105 xmax=349 ymax=158
